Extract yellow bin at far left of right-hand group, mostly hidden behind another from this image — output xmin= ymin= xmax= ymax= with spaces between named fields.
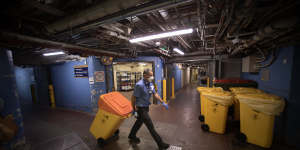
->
xmin=197 ymin=87 xmax=223 ymax=122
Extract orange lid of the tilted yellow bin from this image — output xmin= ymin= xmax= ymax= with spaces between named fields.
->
xmin=98 ymin=92 xmax=133 ymax=117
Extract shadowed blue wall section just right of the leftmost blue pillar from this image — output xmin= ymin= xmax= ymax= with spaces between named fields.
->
xmin=15 ymin=67 xmax=34 ymax=104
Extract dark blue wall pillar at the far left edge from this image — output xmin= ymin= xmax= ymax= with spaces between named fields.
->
xmin=0 ymin=49 xmax=25 ymax=149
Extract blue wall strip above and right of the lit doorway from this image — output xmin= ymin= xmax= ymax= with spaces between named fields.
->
xmin=114 ymin=56 xmax=164 ymax=96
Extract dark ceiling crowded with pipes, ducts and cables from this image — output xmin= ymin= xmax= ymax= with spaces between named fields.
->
xmin=0 ymin=0 xmax=300 ymax=65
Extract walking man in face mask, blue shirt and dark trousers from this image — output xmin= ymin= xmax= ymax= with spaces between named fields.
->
xmin=128 ymin=69 xmax=170 ymax=150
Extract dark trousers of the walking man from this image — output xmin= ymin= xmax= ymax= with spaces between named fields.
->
xmin=129 ymin=107 xmax=162 ymax=146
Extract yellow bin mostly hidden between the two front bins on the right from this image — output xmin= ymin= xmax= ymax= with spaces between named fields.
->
xmin=230 ymin=87 xmax=263 ymax=120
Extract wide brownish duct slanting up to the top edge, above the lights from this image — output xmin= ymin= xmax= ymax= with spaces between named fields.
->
xmin=46 ymin=0 xmax=191 ymax=33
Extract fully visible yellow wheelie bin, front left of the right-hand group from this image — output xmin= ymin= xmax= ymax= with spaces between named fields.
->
xmin=201 ymin=91 xmax=233 ymax=134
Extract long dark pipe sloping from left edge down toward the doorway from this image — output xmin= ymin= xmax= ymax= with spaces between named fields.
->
xmin=0 ymin=31 xmax=126 ymax=57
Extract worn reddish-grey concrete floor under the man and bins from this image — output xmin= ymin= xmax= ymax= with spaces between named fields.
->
xmin=23 ymin=86 xmax=291 ymax=150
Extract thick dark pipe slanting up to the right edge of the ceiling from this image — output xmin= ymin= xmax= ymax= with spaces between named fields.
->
xmin=231 ymin=17 xmax=298 ymax=55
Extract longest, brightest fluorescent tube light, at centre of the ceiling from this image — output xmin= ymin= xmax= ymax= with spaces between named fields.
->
xmin=129 ymin=28 xmax=193 ymax=43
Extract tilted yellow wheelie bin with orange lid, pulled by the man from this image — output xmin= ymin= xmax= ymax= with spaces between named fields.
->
xmin=90 ymin=92 xmax=133 ymax=146
